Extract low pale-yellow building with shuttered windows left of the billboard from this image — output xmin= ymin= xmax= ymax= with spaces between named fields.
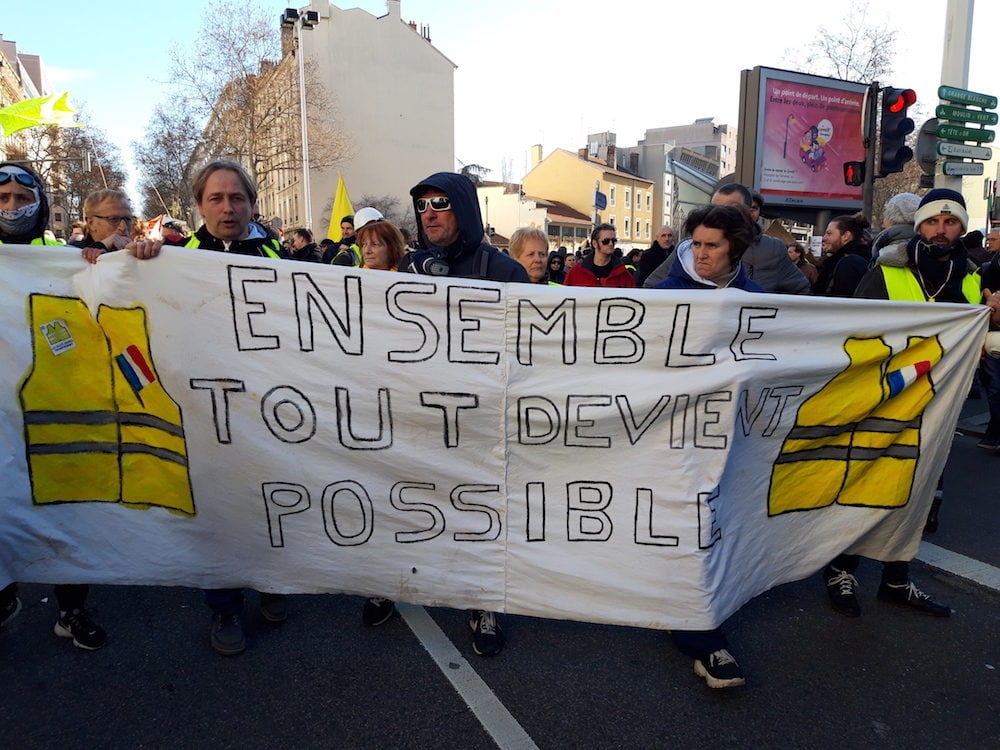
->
xmin=524 ymin=146 xmax=659 ymax=251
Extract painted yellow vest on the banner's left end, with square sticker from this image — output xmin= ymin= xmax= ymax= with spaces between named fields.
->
xmin=20 ymin=294 xmax=195 ymax=515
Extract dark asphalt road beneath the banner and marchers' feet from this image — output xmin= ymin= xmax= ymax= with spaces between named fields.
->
xmin=0 ymin=401 xmax=1000 ymax=750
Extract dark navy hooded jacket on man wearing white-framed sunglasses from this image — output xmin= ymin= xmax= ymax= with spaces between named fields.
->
xmin=399 ymin=172 xmax=531 ymax=284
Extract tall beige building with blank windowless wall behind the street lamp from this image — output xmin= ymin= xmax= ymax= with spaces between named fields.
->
xmin=261 ymin=0 xmax=456 ymax=237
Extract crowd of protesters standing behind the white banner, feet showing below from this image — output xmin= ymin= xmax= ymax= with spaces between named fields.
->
xmin=0 ymin=160 xmax=1000 ymax=688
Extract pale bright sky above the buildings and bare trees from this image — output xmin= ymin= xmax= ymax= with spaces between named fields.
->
xmin=0 ymin=0 xmax=1000 ymax=203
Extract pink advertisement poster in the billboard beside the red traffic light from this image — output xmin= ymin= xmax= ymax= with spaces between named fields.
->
xmin=755 ymin=70 xmax=866 ymax=209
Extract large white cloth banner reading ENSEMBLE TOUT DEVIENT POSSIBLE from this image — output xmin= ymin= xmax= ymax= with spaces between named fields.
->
xmin=0 ymin=246 xmax=986 ymax=629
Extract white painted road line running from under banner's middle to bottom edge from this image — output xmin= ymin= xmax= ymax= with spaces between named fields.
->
xmin=396 ymin=602 xmax=538 ymax=750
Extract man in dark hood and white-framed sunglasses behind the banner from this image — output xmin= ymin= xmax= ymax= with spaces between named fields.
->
xmin=399 ymin=172 xmax=529 ymax=282
